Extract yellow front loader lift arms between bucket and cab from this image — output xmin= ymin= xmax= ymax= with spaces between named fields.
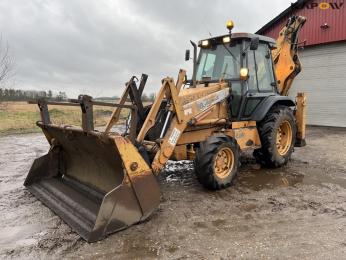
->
xmin=137 ymin=70 xmax=230 ymax=173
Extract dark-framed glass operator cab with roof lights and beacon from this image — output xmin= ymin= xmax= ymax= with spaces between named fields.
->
xmin=186 ymin=21 xmax=278 ymax=120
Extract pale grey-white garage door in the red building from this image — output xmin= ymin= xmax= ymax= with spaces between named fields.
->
xmin=290 ymin=42 xmax=346 ymax=127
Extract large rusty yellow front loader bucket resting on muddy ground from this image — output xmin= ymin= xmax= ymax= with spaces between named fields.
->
xmin=24 ymin=123 xmax=160 ymax=242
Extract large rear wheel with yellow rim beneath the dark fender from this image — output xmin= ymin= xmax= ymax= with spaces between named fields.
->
xmin=254 ymin=106 xmax=297 ymax=168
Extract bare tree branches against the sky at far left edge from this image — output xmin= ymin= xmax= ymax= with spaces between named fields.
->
xmin=0 ymin=36 xmax=14 ymax=85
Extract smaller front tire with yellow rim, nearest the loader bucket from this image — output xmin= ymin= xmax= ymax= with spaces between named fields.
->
xmin=194 ymin=135 xmax=240 ymax=190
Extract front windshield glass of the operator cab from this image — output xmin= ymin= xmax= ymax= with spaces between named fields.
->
xmin=196 ymin=43 xmax=241 ymax=81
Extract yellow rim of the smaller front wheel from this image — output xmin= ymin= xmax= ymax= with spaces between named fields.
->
xmin=214 ymin=147 xmax=234 ymax=179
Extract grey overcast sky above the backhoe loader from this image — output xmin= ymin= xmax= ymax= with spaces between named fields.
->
xmin=0 ymin=0 xmax=292 ymax=97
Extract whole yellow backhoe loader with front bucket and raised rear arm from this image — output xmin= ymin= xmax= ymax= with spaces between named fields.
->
xmin=24 ymin=16 xmax=306 ymax=242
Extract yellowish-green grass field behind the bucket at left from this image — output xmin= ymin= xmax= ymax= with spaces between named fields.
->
xmin=0 ymin=102 xmax=129 ymax=135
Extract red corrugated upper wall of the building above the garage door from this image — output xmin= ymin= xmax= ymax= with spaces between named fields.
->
xmin=261 ymin=0 xmax=346 ymax=45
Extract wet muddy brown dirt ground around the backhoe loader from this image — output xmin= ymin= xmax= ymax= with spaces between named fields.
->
xmin=0 ymin=127 xmax=346 ymax=259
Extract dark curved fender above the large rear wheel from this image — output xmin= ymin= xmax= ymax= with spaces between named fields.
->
xmin=251 ymin=95 xmax=296 ymax=122
